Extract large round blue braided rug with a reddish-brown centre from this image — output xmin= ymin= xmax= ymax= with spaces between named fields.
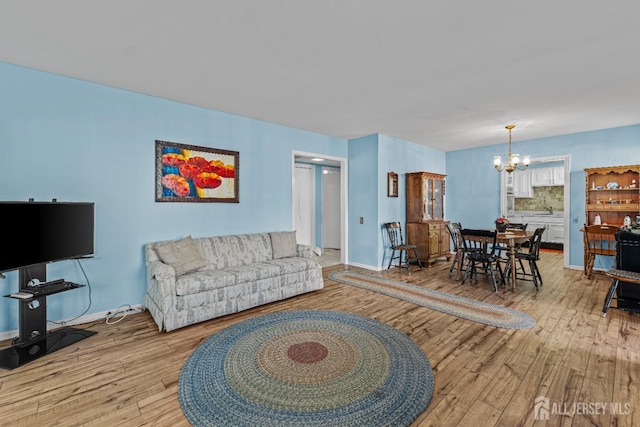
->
xmin=178 ymin=310 xmax=434 ymax=427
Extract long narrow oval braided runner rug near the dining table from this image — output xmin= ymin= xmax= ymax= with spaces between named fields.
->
xmin=327 ymin=271 xmax=536 ymax=329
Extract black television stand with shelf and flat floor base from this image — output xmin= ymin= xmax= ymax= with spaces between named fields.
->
xmin=0 ymin=266 xmax=96 ymax=369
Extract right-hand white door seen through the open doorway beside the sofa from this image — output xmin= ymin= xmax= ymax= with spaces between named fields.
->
xmin=322 ymin=168 xmax=340 ymax=249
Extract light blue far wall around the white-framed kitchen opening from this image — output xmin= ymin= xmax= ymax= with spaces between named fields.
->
xmin=446 ymin=125 xmax=640 ymax=268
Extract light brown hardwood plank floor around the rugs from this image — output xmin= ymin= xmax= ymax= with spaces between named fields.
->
xmin=0 ymin=253 xmax=640 ymax=426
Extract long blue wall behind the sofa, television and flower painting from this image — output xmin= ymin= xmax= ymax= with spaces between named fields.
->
xmin=0 ymin=63 xmax=347 ymax=331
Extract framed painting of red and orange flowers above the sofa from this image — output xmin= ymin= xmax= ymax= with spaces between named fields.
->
xmin=156 ymin=140 xmax=240 ymax=203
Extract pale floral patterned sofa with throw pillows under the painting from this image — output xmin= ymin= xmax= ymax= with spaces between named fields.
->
xmin=142 ymin=232 xmax=324 ymax=331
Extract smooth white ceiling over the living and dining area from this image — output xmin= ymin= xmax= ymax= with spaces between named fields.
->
xmin=0 ymin=0 xmax=640 ymax=151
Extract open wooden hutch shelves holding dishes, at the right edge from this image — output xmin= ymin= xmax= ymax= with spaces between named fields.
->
xmin=584 ymin=165 xmax=640 ymax=226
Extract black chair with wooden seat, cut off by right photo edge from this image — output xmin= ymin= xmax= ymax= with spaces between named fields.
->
xmin=602 ymin=231 xmax=640 ymax=317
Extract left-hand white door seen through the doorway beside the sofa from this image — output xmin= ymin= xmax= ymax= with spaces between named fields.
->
xmin=293 ymin=164 xmax=316 ymax=245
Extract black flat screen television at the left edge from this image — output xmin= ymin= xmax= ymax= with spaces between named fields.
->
xmin=0 ymin=202 xmax=94 ymax=272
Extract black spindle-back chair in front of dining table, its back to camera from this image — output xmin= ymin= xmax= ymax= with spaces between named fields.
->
xmin=460 ymin=228 xmax=505 ymax=292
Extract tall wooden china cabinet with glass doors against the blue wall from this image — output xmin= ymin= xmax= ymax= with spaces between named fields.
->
xmin=405 ymin=172 xmax=451 ymax=265
